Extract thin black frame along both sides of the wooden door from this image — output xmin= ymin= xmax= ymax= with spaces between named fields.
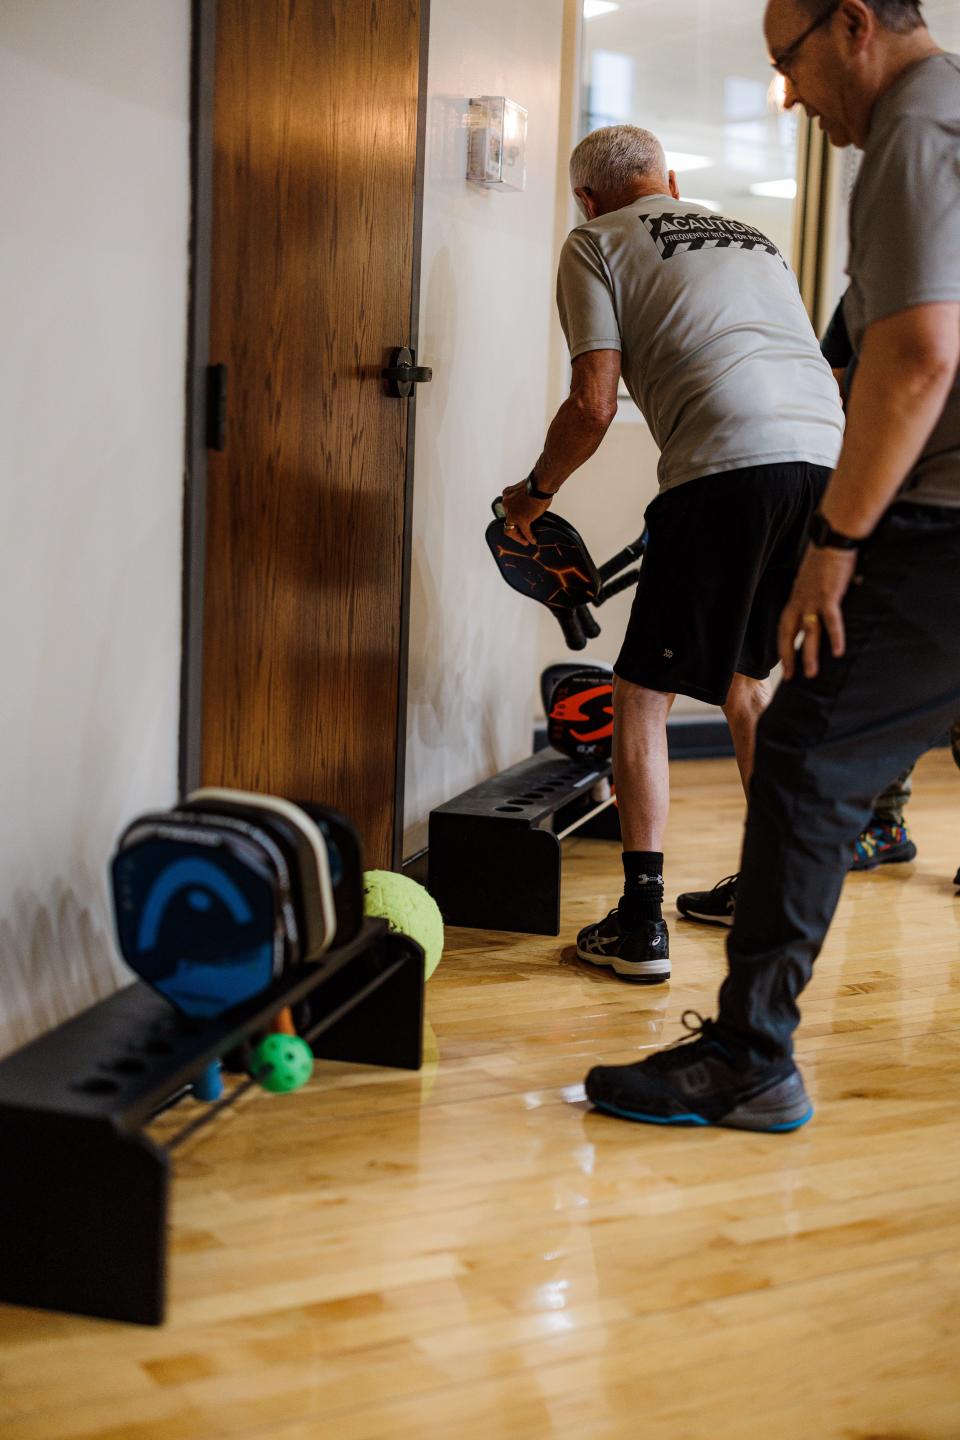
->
xmin=178 ymin=0 xmax=430 ymax=868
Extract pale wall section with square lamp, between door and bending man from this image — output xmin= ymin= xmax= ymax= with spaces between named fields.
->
xmin=404 ymin=0 xmax=563 ymax=855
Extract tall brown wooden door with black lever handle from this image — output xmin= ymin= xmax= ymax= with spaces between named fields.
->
xmin=200 ymin=0 xmax=426 ymax=865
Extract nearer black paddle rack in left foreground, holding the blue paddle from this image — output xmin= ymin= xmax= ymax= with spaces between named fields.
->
xmin=0 ymin=920 xmax=423 ymax=1325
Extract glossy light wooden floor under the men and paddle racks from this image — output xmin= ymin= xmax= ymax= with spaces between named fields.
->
xmin=0 ymin=750 xmax=960 ymax=1440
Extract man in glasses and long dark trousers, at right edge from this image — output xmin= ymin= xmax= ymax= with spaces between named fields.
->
xmin=586 ymin=0 xmax=960 ymax=1130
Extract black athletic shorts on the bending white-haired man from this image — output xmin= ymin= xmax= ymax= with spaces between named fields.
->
xmin=613 ymin=461 xmax=830 ymax=706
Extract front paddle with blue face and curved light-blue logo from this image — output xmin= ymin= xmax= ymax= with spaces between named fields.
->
xmin=112 ymin=837 xmax=282 ymax=1020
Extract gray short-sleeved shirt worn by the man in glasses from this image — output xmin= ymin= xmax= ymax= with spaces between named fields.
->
xmin=843 ymin=55 xmax=960 ymax=505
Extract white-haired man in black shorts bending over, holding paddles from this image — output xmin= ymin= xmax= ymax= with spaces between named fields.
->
xmin=504 ymin=125 xmax=843 ymax=984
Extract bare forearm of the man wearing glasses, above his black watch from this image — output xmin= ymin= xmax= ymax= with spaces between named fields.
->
xmin=820 ymin=318 xmax=956 ymax=539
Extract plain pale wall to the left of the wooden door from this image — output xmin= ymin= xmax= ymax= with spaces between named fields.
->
xmin=0 ymin=0 xmax=190 ymax=1054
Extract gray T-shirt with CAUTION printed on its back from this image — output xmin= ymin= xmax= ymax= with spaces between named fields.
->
xmin=557 ymin=194 xmax=843 ymax=490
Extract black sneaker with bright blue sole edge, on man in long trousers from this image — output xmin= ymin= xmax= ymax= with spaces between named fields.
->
xmin=586 ymin=1009 xmax=813 ymax=1132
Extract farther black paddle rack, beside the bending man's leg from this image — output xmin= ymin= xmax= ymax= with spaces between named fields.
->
xmin=427 ymin=746 xmax=620 ymax=935
